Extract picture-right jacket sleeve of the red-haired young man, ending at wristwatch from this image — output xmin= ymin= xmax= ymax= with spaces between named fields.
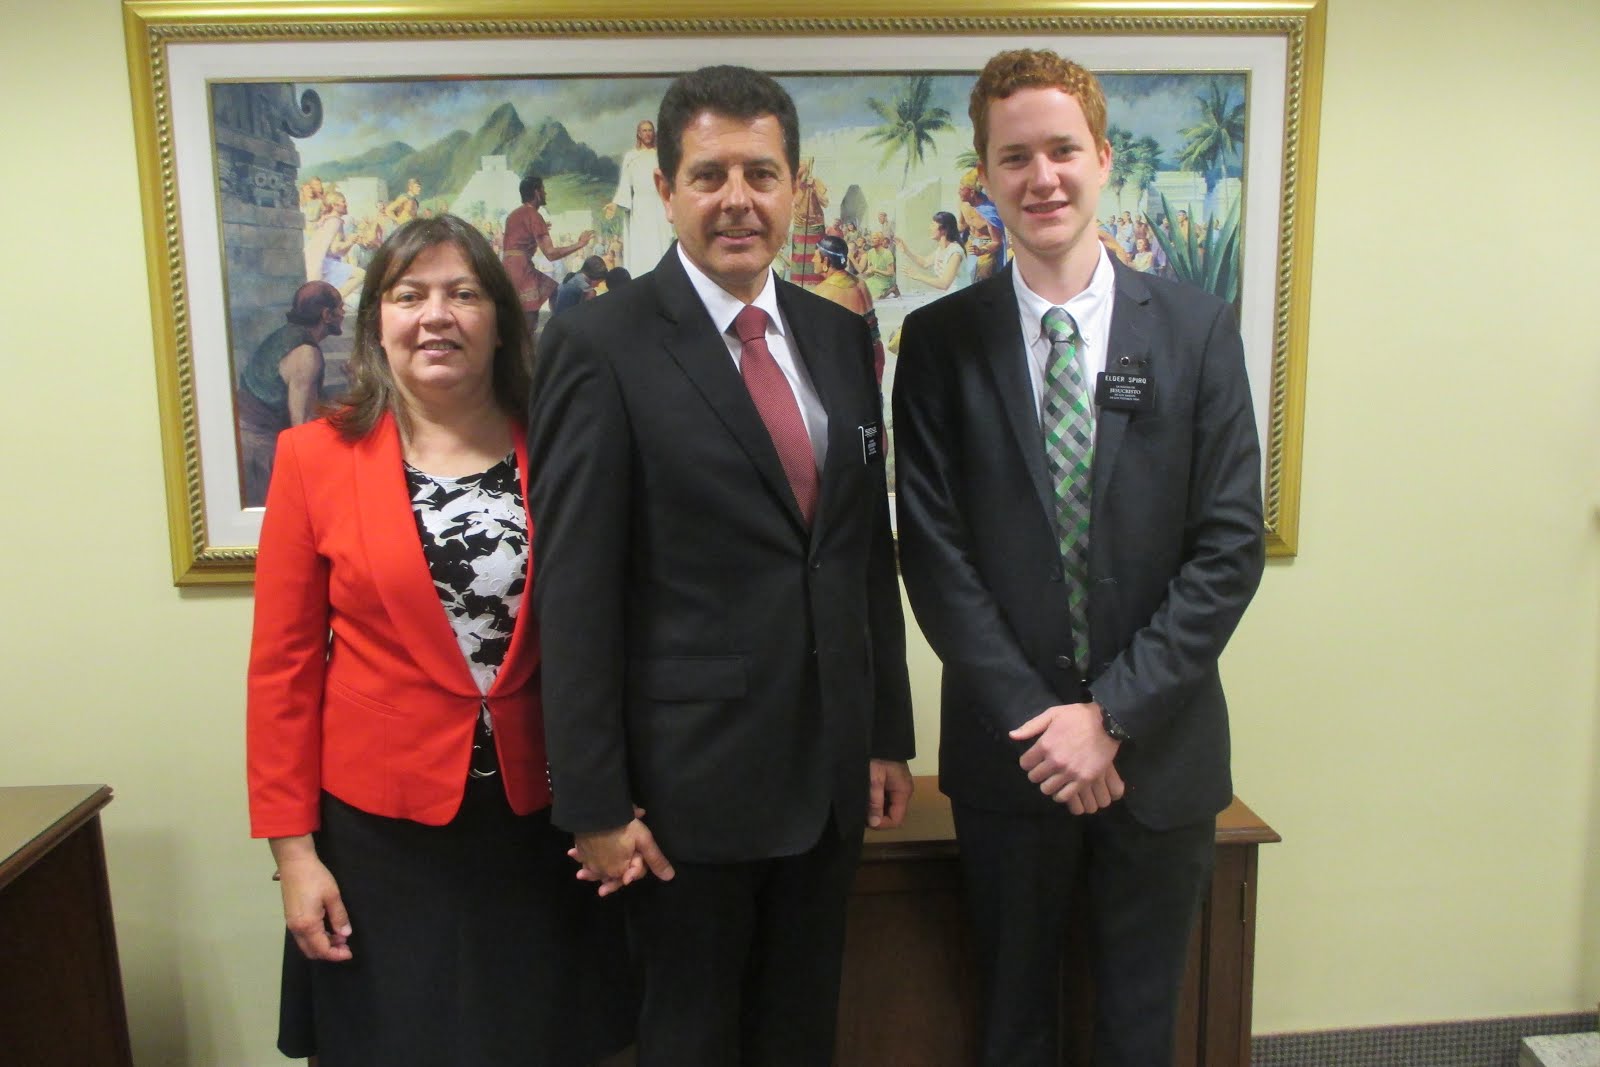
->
xmin=1090 ymin=295 xmax=1266 ymax=739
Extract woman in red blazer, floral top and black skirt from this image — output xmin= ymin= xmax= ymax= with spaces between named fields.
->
xmin=248 ymin=216 xmax=634 ymax=1067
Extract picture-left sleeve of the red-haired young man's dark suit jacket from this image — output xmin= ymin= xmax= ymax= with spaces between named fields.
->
xmin=894 ymin=315 xmax=1061 ymax=734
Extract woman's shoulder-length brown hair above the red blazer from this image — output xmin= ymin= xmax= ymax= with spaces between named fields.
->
xmin=328 ymin=214 xmax=533 ymax=440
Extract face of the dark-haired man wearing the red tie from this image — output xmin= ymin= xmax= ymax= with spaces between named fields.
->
xmin=656 ymin=112 xmax=794 ymax=302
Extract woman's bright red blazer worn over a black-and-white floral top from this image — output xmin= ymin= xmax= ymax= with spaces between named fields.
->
xmin=246 ymin=416 xmax=550 ymax=837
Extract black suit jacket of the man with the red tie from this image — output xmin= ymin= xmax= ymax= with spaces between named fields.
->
xmin=528 ymin=248 xmax=912 ymax=862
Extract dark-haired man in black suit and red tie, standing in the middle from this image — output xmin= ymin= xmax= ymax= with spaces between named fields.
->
xmin=530 ymin=67 xmax=912 ymax=1067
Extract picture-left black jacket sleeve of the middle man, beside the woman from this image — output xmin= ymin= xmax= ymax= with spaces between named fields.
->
xmin=528 ymin=308 xmax=634 ymax=833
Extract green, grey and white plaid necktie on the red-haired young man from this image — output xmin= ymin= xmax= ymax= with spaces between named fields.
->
xmin=1040 ymin=307 xmax=1094 ymax=670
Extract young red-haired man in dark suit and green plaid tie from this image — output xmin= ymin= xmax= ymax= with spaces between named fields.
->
xmin=894 ymin=51 xmax=1264 ymax=1067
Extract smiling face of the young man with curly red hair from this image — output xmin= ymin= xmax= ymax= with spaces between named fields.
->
xmin=981 ymin=88 xmax=1110 ymax=273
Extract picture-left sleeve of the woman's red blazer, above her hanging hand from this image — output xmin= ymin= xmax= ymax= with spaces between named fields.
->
xmin=245 ymin=434 xmax=328 ymax=837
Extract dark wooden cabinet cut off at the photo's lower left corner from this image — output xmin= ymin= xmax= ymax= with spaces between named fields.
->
xmin=0 ymin=785 xmax=133 ymax=1067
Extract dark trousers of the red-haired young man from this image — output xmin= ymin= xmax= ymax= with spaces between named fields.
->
xmin=952 ymin=803 xmax=1216 ymax=1067
